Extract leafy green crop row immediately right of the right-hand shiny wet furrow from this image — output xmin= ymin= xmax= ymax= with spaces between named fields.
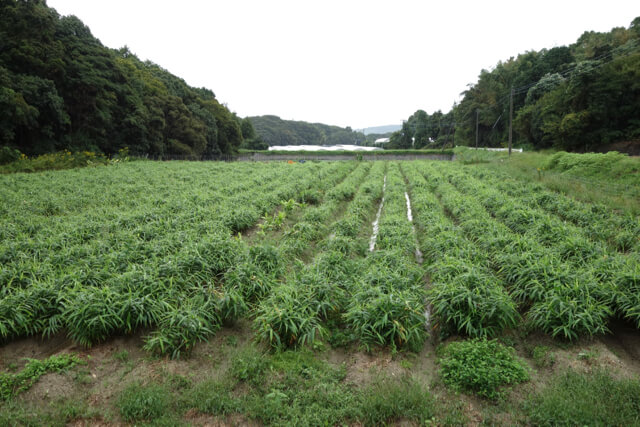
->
xmin=403 ymin=163 xmax=520 ymax=337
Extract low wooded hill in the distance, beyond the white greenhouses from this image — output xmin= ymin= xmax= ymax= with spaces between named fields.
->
xmin=249 ymin=116 xmax=365 ymax=146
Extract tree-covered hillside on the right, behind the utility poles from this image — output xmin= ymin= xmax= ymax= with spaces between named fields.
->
xmin=390 ymin=17 xmax=640 ymax=151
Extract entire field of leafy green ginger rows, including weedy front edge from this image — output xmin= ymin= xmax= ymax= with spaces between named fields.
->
xmin=0 ymin=161 xmax=640 ymax=425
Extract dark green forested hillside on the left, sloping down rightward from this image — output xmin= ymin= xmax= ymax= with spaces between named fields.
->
xmin=0 ymin=0 xmax=242 ymax=157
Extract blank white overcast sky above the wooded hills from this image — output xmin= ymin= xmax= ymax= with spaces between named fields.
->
xmin=47 ymin=0 xmax=640 ymax=129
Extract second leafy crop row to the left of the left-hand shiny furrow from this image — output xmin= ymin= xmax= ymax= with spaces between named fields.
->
xmin=145 ymin=159 xmax=370 ymax=357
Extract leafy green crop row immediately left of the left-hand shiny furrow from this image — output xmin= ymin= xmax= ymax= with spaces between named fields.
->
xmin=248 ymin=162 xmax=384 ymax=348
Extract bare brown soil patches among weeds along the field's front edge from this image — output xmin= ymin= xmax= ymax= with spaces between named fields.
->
xmin=0 ymin=321 xmax=640 ymax=426
